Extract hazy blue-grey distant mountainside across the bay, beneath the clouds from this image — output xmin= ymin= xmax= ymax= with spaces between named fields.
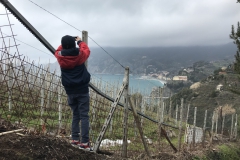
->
xmin=88 ymin=43 xmax=236 ymax=74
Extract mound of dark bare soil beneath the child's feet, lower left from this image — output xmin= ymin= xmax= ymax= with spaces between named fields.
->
xmin=0 ymin=118 xmax=118 ymax=160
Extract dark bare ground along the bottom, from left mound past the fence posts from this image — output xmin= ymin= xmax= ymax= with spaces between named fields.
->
xmin=0 ymin=118 xmax=212 ymax=160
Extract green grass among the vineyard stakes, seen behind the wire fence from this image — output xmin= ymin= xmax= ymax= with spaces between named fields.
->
xmin=0 ymin=82 xmax=189 ymax=151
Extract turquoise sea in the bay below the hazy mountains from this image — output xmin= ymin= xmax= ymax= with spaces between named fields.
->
xmin=91 ymin=74 xmax=166 ymax=95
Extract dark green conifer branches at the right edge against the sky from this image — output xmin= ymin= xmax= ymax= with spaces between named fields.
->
xmin=230 ymin=21 xmax=240 ymax=74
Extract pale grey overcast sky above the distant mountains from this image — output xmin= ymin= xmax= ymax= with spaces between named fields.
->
xmin=0 ymin=0 xmax=240 ymax=62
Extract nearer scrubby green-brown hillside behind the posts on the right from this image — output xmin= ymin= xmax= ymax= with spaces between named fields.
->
xmin=168 ymin=73 xmax=240 ymax=127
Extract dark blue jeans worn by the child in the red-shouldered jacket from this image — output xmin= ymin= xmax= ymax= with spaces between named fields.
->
xmin=68 ymin=93 xmax=89 ymax=143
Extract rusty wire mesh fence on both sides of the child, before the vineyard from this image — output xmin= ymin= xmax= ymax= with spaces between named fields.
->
xmin=0 ymin=45 xmax=180 ymax=154
